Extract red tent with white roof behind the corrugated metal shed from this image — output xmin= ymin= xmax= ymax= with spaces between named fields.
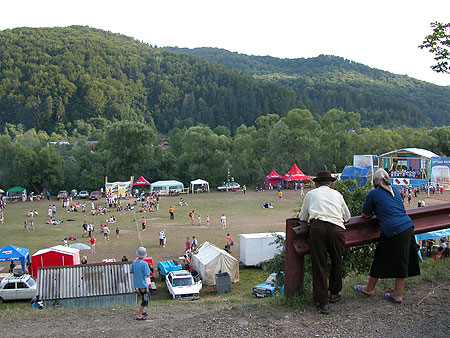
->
xmin=31 ymin=245 xmax=80 ymax=278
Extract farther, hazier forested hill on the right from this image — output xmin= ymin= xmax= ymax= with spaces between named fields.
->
xmin=166 ymin=47 xmax=450 ymax=127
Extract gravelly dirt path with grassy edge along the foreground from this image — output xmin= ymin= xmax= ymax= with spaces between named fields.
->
xmin=0 ymin=279 xmax=450 ymax=338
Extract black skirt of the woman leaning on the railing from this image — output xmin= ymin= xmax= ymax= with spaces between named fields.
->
xmin=370 ymin=227 xmax=420 ymax=278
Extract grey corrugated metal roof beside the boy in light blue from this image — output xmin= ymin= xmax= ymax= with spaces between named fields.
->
xmin=37 ymin=262 xmax=135 ymax=300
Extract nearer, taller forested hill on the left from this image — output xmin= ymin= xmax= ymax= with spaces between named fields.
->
xmin=0 ymin=26 xmax=298 ymax=132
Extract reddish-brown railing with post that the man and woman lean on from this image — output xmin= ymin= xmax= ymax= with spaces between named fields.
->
xmin=284 ymin=203 xmax=450 ymax=293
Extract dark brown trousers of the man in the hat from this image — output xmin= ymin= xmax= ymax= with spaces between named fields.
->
xmin=309 ymin=219 xmax=345 ymax=304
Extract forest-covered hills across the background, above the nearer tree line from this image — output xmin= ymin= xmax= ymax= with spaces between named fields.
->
xmin=0 ymin=26 xmax=450 ymax=134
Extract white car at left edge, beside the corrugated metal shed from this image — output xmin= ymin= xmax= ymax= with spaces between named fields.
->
xmin=0 ymin=274 xmax=37 ymax=304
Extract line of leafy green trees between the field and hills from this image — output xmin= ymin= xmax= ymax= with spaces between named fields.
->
xmin=0 ymin=109 xmax=450 ymax=193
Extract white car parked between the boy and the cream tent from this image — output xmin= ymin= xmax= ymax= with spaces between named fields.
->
xmin=166 ymin=270 xmax=202 ymax=299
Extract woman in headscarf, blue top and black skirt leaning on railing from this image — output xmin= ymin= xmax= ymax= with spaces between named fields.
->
xmin=354 ymin=169 xmax=420 ymax=304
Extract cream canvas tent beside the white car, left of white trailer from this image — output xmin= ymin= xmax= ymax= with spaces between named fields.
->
xmin=191 ymin=242 xmax=239 ymax=285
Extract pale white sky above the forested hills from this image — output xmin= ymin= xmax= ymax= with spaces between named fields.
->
xmin=0 ymin=0 xmax=450 ymax=86
